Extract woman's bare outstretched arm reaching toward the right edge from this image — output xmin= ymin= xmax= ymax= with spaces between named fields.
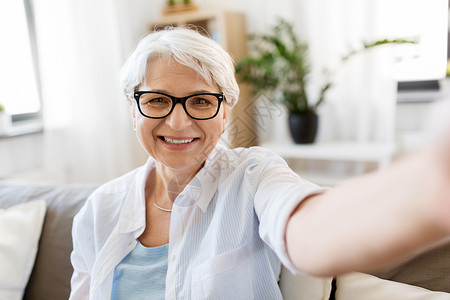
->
xmin=286 ymin=108 xmax=450 ymax=276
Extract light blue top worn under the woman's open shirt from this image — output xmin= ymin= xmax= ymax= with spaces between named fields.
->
xmin=111 ymin=241 xmax=169 ymax=300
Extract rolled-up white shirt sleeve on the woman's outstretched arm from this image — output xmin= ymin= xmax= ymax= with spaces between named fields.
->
xmin=254 ymin=152 xmax=325 ymax=274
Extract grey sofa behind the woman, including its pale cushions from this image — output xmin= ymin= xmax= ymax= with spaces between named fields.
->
xmin=0 ymin=179 xmax=450 ymax=300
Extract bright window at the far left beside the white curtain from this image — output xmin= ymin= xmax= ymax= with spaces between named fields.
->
xmin=0 ymin=0 xmax=41 ymax=125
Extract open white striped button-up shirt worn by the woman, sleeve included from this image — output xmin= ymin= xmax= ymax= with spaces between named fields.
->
xmin=70 ymin=146 xmax=322 ymax=300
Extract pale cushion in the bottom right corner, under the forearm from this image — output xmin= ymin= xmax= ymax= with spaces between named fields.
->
xmin=336 ymin=273 xmax=450 ymax=300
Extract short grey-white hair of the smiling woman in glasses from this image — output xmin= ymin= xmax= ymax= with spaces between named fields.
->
xmin=121 ymin=27 xmax=239 ymax=107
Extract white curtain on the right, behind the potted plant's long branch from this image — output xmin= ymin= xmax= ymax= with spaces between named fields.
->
xmin=297 ymin=0 xmax=396 ymax=142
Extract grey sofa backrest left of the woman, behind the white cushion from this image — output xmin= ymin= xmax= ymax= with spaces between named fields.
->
xmin=0 ymin=180 xmax=95 ymax=300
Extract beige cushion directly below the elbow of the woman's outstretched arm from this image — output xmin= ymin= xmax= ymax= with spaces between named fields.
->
xmin=280 ymin=267 xmax=332 ymax=300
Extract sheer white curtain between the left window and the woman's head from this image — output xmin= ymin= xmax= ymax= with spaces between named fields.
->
xmin=34 ymin=0 xmax=146 ymax=182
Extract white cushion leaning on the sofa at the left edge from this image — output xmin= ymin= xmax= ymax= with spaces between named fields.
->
xmin=0 ymin=200 xmax=46 ymax=300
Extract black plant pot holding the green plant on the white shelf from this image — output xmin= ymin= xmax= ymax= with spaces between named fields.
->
xmin=289 ymin=112 xmax=319 ymax=144
